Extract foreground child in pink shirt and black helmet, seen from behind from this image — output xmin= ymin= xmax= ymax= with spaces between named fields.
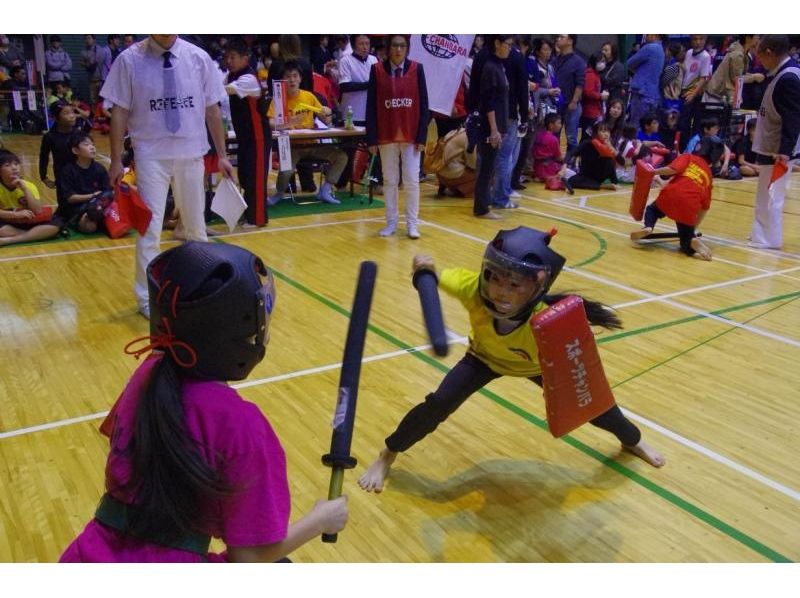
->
xmin=61 ymin=242 xmax=347 ymax=562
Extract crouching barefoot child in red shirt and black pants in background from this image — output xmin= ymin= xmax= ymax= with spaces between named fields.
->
xmin=631 ymin=137 xmax=724 ymax=261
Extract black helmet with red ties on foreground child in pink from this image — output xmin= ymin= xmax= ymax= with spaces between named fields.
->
xmin=147 ymin=241 xmax=275 ymax=380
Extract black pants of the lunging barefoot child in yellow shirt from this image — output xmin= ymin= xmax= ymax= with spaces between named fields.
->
xmin=386 ymin=353 xmax=642 ymax=453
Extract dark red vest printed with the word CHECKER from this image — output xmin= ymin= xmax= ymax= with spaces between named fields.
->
xmin=372 ymin=61 xmax=419 ymax=145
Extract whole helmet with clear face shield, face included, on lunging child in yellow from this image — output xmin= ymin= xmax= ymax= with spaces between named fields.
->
xmin=478 ymin=226 xmax=566 ymax=320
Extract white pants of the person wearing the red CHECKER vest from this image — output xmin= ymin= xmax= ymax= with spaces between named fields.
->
xmin=378 ymin=143 xmax=420 ymax=227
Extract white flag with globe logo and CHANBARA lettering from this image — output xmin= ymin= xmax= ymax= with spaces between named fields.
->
xmin=408 ymin=33 xmax=475 ymax=116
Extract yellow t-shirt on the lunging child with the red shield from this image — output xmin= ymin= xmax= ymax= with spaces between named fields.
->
xmin=439 ymin=268 xmax=547 ymax=378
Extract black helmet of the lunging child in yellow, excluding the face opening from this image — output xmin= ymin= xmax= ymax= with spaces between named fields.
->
xmin=478 ymin=226 xmax=567 ymax=320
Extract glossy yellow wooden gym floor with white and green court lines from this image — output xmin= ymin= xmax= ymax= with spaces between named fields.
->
xmin=0 ymin=136 xmax=800 ymax=562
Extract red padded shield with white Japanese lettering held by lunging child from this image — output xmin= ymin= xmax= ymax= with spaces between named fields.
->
xmin=531 ymin=295 xmax=614 ymax=438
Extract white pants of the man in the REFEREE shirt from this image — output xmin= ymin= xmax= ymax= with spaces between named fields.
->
xmin=133 ymin=156 xmax=208 ymax=307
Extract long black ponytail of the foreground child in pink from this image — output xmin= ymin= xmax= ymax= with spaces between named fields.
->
xmin=117 ymin=353 xmax=231 ymax=542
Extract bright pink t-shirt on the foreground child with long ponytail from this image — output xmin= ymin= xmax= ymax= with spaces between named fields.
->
xmin=61 ymin=357 xmax=291 ymax=562
